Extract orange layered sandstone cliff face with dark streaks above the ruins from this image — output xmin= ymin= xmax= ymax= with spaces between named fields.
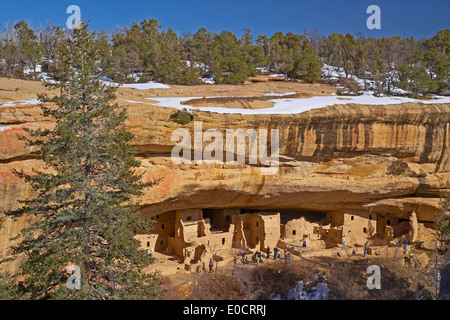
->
xmin=0 ymin=100 xmax=450 ymax=268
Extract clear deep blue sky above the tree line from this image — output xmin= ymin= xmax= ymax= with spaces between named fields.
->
xmin=0 ymin=0 xmax=450 ymax=38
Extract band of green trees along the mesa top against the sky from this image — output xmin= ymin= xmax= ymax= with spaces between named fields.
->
xmin=0 ymin=19 xmax=450 ymax=96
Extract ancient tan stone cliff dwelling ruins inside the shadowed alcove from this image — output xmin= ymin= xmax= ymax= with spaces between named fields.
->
xmin=136 ymin=208 xmax=433 ymax=271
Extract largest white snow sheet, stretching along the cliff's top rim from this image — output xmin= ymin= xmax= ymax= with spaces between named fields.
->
xmin=146 ymin=92 xmax=450 ymax=114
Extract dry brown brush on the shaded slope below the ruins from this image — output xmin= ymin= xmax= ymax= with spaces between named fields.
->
xmin=178 ymin=252 xmax=433 ymax=300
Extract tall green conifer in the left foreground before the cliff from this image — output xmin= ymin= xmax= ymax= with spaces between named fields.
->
xmin=3 ymin=24 xmax=160 ymax=299
